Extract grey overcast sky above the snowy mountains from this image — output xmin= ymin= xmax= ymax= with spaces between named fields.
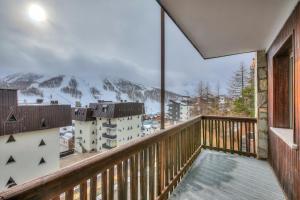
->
xmin=0 ymin=0 xmax=254 ymax=93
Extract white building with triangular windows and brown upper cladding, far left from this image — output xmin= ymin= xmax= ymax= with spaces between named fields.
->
xmin=0 ymin=89 xmax=71 ymax=191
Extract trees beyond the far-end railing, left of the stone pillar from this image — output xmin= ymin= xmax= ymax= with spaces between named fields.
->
xmin=192 ymin=60 xmax=255 ymax=117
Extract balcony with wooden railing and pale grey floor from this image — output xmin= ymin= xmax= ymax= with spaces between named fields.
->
xmin=0 ymin=116 xmax=284 ymax=200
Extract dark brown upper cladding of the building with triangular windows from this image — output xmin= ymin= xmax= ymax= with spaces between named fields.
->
xmin=0 ymin=89 xmax=72 ymax=136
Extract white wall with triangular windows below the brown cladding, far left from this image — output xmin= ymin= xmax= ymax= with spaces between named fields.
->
xmin=0 ymin=128 xmax=59 ymax=191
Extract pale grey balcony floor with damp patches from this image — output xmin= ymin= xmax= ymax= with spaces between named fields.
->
xmin=170 ymin=150 xmax=285 ymax=200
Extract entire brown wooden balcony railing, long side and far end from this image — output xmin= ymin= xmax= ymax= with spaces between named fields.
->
xmin=0 ymin=116 xmax=256 ymax=200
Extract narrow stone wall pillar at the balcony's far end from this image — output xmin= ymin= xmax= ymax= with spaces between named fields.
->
xmin=255 ymin=51 xmax=268 ymax=159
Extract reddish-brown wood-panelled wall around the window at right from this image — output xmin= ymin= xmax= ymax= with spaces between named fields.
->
xmin=268 ymin=4 xmax=300 ymax=199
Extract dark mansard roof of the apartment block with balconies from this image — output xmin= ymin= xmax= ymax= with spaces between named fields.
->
xmin=72 ymin=102 xmax=145 ymax=121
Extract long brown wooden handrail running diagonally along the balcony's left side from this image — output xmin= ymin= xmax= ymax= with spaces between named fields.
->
xmin=0 ymin=116 xmax=201 ymax=200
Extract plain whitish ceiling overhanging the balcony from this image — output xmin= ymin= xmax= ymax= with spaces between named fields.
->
xmin=158 ymin=0 xmax=299 ymax=58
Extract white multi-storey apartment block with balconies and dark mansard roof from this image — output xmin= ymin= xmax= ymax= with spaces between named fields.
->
xmin=73 ymin=102 xmax=144 ymax=153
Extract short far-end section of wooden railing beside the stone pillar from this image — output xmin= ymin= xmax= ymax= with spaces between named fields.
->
xmin=201 ymin=116 xmax=257 ymax=157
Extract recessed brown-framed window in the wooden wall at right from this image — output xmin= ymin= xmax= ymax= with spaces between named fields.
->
xmin=273 ymin=36 xmax=295 ymax=129
